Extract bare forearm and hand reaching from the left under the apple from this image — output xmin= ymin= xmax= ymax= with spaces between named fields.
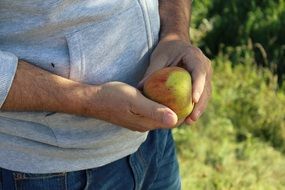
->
xmin=2 ymin=61 xmax=177 ymax=132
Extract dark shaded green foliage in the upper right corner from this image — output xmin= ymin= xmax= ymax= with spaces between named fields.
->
xmin=192 ymin=0 xmax=285 ymax=83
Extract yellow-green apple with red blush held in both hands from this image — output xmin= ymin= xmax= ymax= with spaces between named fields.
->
xmin=143 ymin=67 xmax=193 ymax=119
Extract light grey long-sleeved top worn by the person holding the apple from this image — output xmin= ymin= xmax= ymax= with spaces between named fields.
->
xmin=0 ymin=0 xmax=160 ymax=173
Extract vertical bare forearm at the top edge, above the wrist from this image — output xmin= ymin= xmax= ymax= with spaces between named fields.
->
xmin=159 ymin=0 xmax=191 ymax=42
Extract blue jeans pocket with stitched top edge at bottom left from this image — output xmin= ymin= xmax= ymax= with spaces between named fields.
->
xmin=13 ymin=172 xmax=67 ymax=190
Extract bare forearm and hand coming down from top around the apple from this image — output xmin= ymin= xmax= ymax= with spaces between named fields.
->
xmin=139 ymin=0 xmax=212 ymax=124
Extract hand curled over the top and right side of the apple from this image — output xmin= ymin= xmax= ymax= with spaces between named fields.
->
xmin=138 ymin=40 xmax=212 ymax=124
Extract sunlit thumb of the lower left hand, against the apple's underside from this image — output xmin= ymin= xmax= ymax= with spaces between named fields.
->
xmin=137 ymin=96 xmax=178 ymax=128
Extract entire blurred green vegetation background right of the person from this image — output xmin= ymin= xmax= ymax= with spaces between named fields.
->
xmin=173 ymin=0 xmax=285 ymax=190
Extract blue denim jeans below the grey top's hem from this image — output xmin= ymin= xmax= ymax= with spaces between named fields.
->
xmin=0 ymin=129 xmax=181 ymax=190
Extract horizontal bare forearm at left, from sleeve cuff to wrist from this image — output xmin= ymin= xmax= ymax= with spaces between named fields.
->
xmin=1 ymin=61 xmax=98 ymax=115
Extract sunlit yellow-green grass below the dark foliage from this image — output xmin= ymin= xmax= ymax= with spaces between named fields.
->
xmin=174 ymin=60 xmax=285 ymax=190
